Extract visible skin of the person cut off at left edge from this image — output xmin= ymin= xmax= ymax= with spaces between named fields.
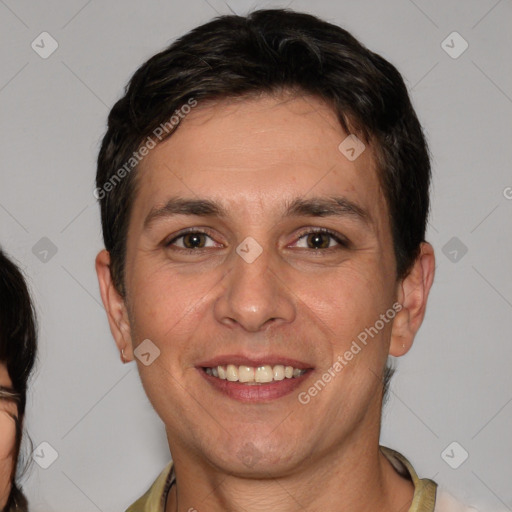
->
xmin=0 ymin=363 xmax=16 ymax=510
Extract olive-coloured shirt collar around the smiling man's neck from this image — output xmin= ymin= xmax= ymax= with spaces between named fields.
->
xmin=126 ymin=446 xmax=475 ymax=512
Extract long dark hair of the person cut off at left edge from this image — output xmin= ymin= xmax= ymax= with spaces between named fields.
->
xmin=0 ymin=249 xmax=37 ymax=512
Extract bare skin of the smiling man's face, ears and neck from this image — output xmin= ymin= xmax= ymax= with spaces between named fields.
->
xmin=96 ymin=96 xmax=434 ymax=512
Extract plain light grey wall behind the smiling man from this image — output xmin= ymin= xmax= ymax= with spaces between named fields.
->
xmin=0 ymin=0 xmax=512 ymax=512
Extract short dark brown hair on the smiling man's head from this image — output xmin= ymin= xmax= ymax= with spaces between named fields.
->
xmin=96 ymin=9 xmax=431 ymax=400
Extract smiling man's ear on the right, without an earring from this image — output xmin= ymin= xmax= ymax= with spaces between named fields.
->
xmin=389 ymin=242 xmax=435 ymax=357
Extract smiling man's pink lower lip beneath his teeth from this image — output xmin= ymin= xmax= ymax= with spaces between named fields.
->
xmin=198 ymin=368 xmax=312 ymax=402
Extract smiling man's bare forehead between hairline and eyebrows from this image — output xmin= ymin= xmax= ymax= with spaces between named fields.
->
xmin=130 ymin=95 xmax=385 ymax=229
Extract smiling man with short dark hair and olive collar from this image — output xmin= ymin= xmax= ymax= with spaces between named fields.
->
xmin=95 ymin=10 xmax=478 ymax=512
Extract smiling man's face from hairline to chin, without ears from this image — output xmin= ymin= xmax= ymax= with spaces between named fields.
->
xmin=125 ymin=97 xmax=397 ymax=474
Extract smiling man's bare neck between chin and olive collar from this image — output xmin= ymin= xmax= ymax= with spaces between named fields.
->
xmin=165 ymin=428 xmax=414 ymax=512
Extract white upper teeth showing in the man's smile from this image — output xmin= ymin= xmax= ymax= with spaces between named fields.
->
xmin=205 ymin=364 xmax=306 ymax=382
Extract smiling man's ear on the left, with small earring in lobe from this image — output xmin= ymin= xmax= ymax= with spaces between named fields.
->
xmin=96 ymin=249 xmax=133 ymax=362
